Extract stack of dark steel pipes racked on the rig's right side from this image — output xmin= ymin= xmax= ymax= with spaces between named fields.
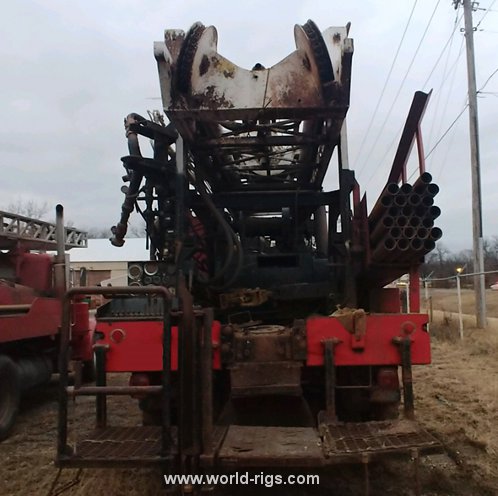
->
xmin=368 ymin=172 xmax=443 ymax=264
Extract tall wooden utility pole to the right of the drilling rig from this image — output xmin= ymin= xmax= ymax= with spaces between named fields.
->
xmin=453 ymin=0 xmax=486 ymax=329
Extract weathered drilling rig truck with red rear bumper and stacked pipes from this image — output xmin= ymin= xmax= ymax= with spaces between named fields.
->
xmin=57 ymin=21 xmax=441 ymax=492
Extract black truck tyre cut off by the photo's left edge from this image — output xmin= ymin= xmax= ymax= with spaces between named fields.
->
xmin=0 ymin=355 xmax=21 ymax=441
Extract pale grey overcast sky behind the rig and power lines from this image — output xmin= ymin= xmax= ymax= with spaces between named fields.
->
xmin=0 ymin=0 xmax=498 ymax=251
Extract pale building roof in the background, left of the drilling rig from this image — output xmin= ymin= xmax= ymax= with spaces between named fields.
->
xmin=69 ymin=238 xmax=150 ymax=262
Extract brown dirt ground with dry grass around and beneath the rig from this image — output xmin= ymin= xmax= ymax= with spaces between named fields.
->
xmin=0 ymin=293 xmax=498 ymax=496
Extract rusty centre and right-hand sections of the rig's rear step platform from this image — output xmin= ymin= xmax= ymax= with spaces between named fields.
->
xmin=217 ymin=420 xmax=442 ymax=467
